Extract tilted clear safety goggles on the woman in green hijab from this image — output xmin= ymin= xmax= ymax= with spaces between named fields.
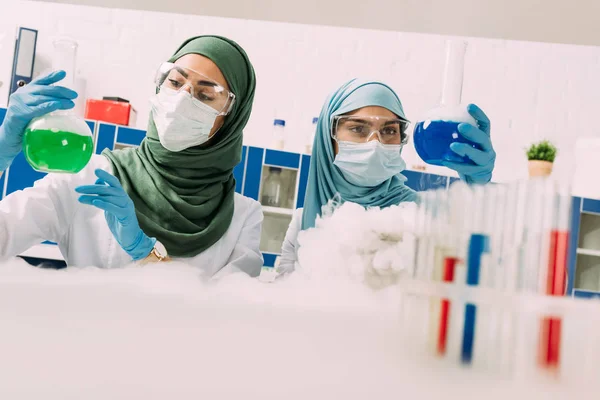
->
xmin=154 ymin=62 xmax=235 ymax=115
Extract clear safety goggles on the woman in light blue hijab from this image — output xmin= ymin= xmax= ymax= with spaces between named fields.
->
xmin=331 ymin=115 xmax=410 ymax=145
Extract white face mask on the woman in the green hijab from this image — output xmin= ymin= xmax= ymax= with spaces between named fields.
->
xmin=150 ymin=87 xmax=219 ymax=152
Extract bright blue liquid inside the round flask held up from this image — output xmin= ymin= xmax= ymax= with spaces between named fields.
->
xmin=414 ymin=121 xmax=480 ymax=166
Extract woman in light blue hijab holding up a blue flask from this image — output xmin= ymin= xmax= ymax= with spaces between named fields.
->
xmin=280 ymin=79 xmax=495 ymax=271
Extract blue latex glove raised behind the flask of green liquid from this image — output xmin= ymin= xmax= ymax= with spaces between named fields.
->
xmin=0 ymin=71 xmax=77 ymax=171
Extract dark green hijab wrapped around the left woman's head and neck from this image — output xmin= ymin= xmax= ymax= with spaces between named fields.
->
xmin=103 ymin=36 xmax=256 ymax=257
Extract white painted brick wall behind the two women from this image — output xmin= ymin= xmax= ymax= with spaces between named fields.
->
xmin=0 ymin=0 xmax=600 ymax=181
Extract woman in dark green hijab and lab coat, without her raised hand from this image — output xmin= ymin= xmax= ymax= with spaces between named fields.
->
xmin=0 ymin=36 xmax=263 ymax=276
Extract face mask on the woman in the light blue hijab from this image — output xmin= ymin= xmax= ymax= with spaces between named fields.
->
xmin=333 ymin=140 xmax=406 ymax=187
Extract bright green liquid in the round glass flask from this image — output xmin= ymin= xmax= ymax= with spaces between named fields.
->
xmin=23 ymin=129 xmax=94 ymax=174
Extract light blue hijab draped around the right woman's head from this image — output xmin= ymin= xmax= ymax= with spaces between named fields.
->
xmin=302 ymin=79 xmax=417 ymax=230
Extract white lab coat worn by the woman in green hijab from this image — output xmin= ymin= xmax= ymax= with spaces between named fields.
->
xmin=0 ymin=155 xmax=263 ymax=277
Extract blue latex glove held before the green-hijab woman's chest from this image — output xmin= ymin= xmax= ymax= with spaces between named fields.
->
xmin=75 ymin=169 xmax=156 ymax=261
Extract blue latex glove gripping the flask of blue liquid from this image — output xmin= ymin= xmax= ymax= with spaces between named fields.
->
xmin=444 ymin=104 xmax=496 ymax=184
